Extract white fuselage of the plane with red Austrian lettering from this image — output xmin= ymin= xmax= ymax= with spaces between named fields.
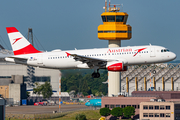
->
xmin=6 ymin=45 xmax=176 ymax=69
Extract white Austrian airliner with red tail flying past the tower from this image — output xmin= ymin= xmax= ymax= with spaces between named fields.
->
xmin=5 ymin=27 xmax=176 ymax=78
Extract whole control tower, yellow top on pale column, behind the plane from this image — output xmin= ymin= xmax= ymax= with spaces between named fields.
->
xmin=98 ymin=0 xmax=132 ymax=97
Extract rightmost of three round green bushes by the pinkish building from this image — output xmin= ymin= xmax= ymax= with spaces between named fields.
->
xmin=123 ymin=106 xmax=135 ymax=118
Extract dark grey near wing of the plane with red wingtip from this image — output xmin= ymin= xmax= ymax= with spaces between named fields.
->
xmin=66 ymin=52 xmax=107 ymax=68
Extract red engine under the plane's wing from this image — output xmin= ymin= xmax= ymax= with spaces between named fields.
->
xmin=107 ymin=63 xmax=127 ymax=71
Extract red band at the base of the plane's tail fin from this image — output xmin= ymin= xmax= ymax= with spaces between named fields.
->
xmin=13 ymin=44 xmax=41 ymax=55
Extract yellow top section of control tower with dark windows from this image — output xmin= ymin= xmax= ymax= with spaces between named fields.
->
xmin=98 ymin=12 xmax=132 ymax=40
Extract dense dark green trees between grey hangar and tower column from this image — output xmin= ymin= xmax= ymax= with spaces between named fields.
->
xmin=61 ymin=69 xmax=108 ymax=96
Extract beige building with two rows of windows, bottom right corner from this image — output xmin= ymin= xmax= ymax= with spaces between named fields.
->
xmin=140 ymin=101 xmax=180 ymax=120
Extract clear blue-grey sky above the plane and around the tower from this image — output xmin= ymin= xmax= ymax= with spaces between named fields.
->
xmin=0 ymin=0 xmax=180 ymax=60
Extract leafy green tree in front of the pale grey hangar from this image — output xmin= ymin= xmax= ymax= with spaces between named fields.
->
xmin=33 ymin=81 xmax=53 ymax=98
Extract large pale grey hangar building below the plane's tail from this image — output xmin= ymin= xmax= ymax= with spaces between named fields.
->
xmin=0 ymin=62 xmax=60 ymax=91
